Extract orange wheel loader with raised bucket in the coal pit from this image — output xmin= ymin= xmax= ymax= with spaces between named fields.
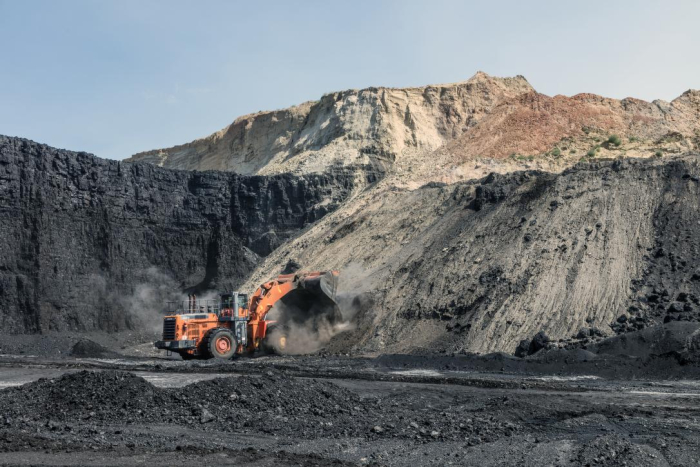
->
xmin=154 ymin=271 xmax=340 ymax=360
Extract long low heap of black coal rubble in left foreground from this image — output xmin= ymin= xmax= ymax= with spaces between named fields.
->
xmin=0 ymin=371 xmax=519 ymax=443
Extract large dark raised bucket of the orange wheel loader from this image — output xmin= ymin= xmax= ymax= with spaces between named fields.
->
xmin=279 ymin=272 xmax=342 ymax=328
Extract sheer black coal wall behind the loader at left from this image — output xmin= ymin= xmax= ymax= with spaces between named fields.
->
xmin=0 ymin=136 xmax=382 ymax=332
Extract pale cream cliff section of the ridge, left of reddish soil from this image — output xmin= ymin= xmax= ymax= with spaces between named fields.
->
xmin=127 ymin=72 xmax=532 ymax=175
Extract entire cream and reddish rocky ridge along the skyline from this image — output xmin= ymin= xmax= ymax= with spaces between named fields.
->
xmin=128 ymin=72 xmax=700 ymax=187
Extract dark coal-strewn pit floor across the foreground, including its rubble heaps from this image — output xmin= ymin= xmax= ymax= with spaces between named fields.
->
xmin=0 ymin=355 xmax=700 ymax=466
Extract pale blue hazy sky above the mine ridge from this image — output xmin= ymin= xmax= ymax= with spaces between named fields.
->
xmin=0 ymin=0 xmax=700 ymax=159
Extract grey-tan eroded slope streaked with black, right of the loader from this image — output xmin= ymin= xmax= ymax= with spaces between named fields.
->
xmin=248 ymin=154 xmax=700 ymax=352
